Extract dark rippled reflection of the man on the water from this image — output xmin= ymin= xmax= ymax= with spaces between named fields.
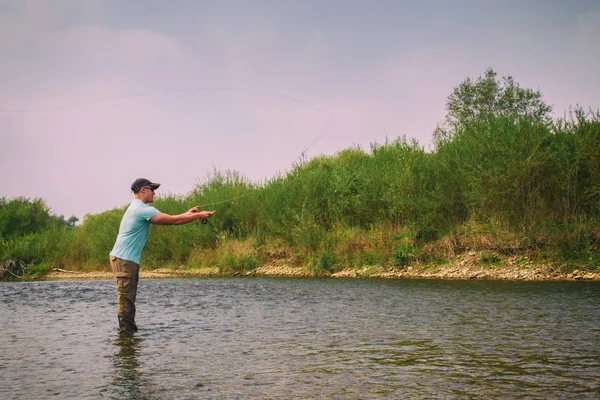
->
xmin=111 ymin=333 xmax=148 ymax=400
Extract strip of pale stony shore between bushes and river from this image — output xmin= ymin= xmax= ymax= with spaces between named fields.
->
xmin=41 ymin=252 xmax=600 ymax=281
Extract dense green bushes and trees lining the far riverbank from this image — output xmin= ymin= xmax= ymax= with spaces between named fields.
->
xmin=0 ymin=69 xmax=600 ymax=275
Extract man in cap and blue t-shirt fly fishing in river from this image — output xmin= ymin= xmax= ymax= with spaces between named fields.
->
xmin=110 ymin=178 xmax=214 ymax=333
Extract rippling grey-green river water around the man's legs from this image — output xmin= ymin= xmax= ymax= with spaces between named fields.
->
xmin=0 ymin=278 xmax=600 ymax=399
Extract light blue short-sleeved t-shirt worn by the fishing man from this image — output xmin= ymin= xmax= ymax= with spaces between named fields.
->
xmin=110 ymin=199 xmax=160 ymax=264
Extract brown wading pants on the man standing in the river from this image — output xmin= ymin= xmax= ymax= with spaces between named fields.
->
xmin=110 ymin=256 xmax=140 ymax=333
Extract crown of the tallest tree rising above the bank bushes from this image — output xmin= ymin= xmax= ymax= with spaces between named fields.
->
xmin=434 ymin=67 xmax=552 ymax=144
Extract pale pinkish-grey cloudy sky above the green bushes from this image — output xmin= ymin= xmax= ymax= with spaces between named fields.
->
xmin=0 ymin=0 xmax=600 ymax=220
